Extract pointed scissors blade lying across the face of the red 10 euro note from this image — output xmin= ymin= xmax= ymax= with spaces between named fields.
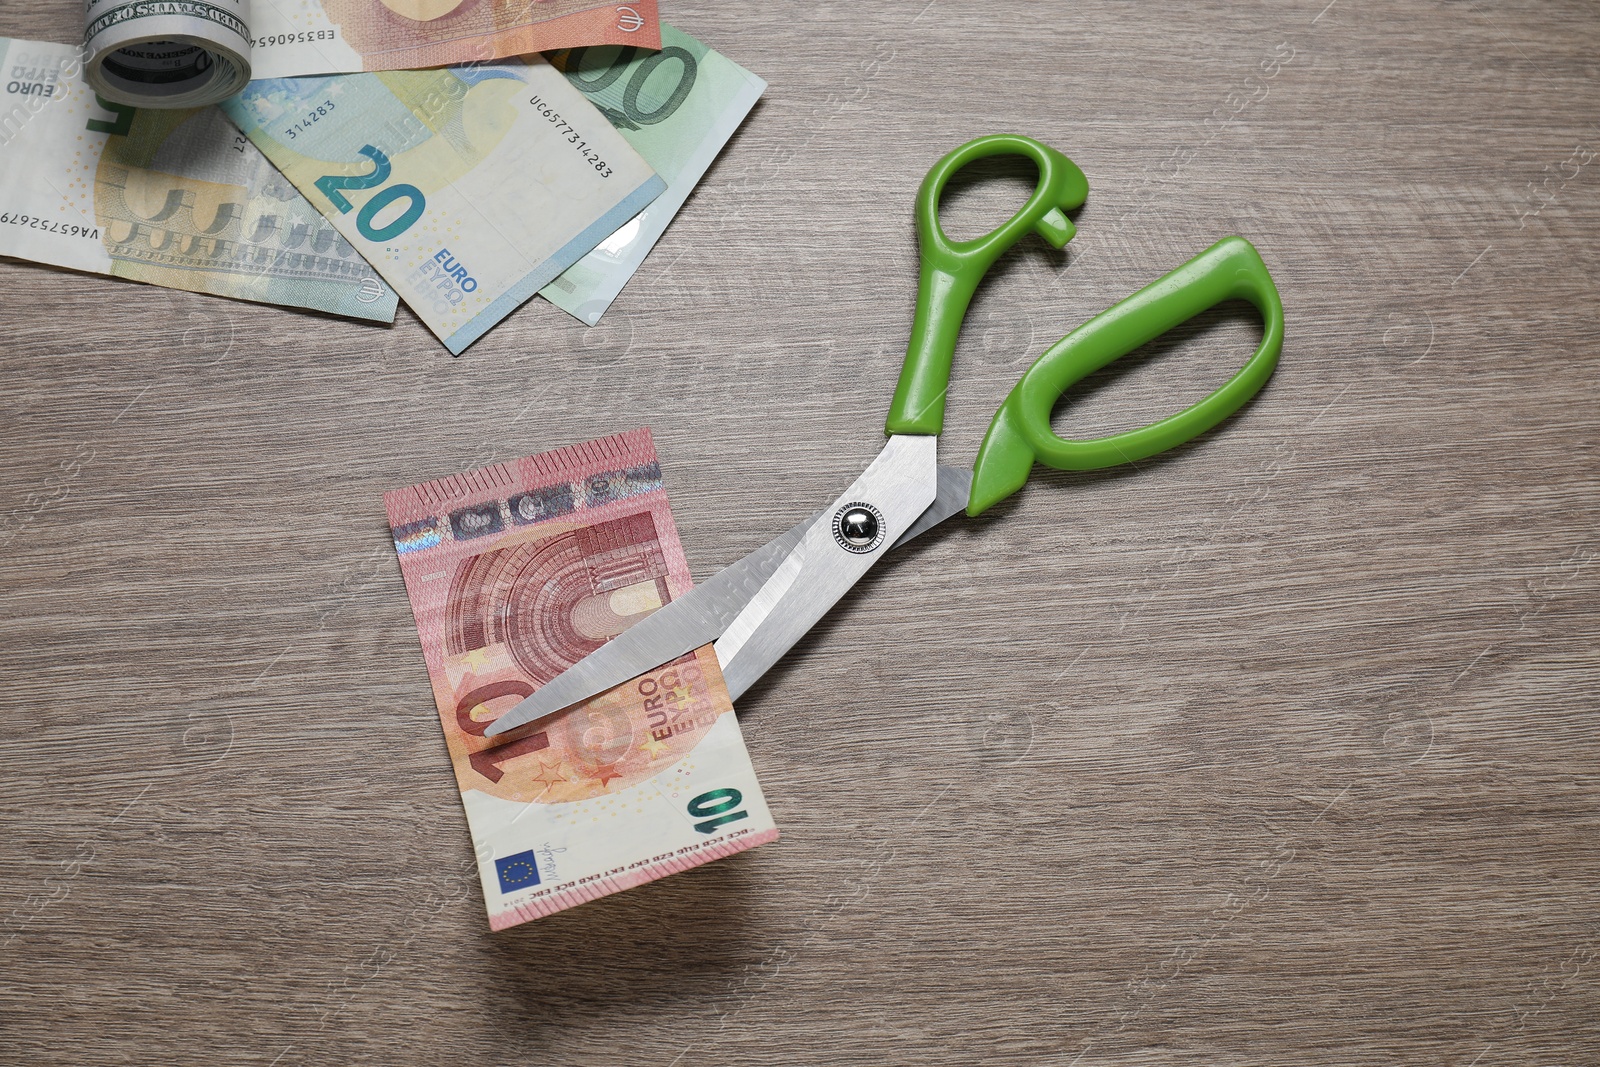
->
xmin=483 ymin=515 xmax=816 ymax=737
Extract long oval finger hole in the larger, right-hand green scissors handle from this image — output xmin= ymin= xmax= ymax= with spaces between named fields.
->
xmin=1050 ymin=301 xmax=1262 ymax=440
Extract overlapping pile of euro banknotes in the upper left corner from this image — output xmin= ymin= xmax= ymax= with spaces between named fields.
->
xmin=0 ymin=0 xmax=766 ymax=343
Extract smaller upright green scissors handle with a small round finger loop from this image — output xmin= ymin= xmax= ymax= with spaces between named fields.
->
xmin=888 ymin=134 xmax=1090 ymax=435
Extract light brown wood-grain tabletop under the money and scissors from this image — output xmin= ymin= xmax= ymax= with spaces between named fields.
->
xmin=0 ymin=0 xmax=1600 ymax=1067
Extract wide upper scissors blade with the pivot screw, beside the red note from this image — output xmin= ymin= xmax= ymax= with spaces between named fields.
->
xmin=715 ymin=434 xmax=939 ymax=701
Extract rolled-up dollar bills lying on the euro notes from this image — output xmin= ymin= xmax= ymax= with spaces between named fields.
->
xmin=83 ymin=0 xmax=250 ymax=107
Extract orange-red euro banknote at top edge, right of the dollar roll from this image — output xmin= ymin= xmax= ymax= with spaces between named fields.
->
xmin=250 ymin=0 xmax=661 ymax=78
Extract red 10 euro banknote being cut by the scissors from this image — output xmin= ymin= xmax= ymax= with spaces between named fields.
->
xmin=384 ymin=429 xmax=778 ymax=929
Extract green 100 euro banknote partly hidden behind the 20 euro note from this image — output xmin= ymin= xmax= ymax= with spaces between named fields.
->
xmin=539 ymin=24 xmax=766 ymax=326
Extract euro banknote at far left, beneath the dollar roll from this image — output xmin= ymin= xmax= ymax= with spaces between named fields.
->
xmin=0 ymin=37 xmax=395 ymax=322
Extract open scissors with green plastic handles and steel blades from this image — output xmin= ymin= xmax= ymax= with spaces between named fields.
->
xmin=486 ymin=134 xmax=1283 ymax=736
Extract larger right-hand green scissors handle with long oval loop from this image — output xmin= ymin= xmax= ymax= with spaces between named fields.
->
xmin=966 ymin=237 xmax=1283 ymax=515
